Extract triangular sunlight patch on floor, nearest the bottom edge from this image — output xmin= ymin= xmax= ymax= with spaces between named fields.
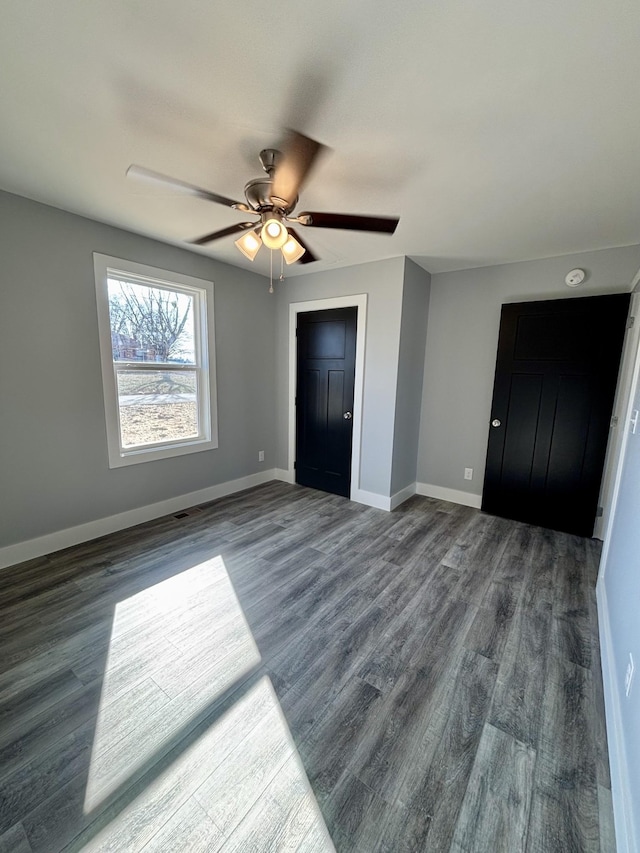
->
xmin=82 ymin=676 xmax=335 ymax=853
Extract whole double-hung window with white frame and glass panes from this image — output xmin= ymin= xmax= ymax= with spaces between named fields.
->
xmin=93 ymin=253 xmax=218 ymax=468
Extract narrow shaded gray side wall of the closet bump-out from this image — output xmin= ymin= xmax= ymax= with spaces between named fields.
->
xmin=391 ymin=258 xmax=431 ymax=495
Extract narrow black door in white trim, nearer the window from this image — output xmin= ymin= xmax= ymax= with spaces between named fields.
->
xmin=296 ymin=308 xmax=358 ymax=497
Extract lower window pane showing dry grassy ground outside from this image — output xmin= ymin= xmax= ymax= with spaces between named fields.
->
xmin=117 ymin=370 xmax=199 ymax=448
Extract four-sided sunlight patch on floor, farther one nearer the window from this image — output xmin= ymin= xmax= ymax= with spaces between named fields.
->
xmin=84 ymin=556 xmax=260 ymax=812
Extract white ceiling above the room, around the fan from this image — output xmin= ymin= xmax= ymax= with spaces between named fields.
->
xmin=0 ymin=0 xmax=640 ymax=274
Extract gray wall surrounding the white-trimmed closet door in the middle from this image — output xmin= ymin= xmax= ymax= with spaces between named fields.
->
xmin=275 ymin=258 xmax=404 ymax=496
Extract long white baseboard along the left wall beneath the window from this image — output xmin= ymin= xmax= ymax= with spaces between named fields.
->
xmin=0 ymin=468 xmax=278 ymax=569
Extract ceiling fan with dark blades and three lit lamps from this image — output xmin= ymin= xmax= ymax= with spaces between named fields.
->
xmin=127 ymin=130 xmax=400 ymax=264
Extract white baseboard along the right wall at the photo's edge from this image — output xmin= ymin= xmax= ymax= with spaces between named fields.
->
xmin=596 ymin=582 xmax=639 ymax=853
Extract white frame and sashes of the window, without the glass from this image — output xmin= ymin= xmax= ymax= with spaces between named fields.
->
xmin=93 ymin=252 xmax=218 ymax=468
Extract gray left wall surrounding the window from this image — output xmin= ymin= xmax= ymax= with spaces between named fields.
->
xmin=0 ymin=193 xmax=276 ymax=546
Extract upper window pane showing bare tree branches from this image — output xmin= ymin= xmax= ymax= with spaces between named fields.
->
xmin=108 ymin=278 xmax=196 ymax=364
